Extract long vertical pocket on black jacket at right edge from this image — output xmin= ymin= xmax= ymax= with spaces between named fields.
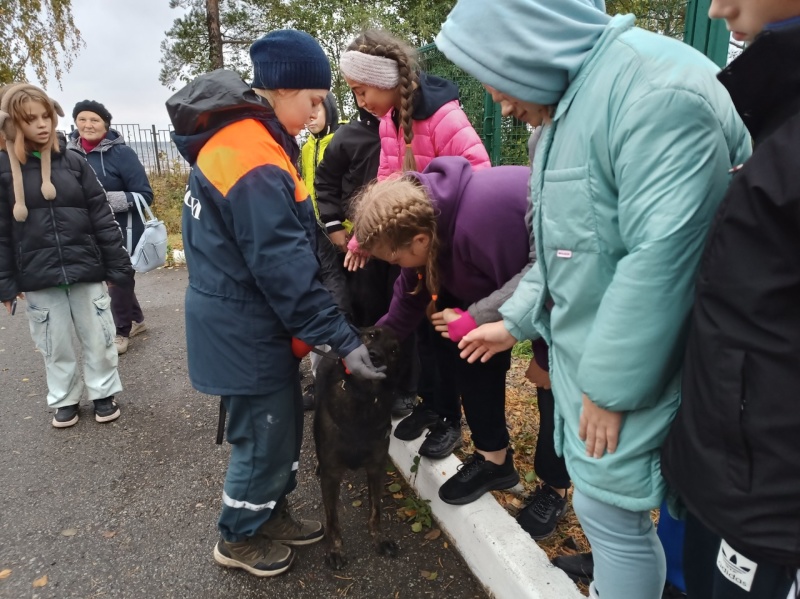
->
xmin=716 ymin=348 xmax=752 ymax=493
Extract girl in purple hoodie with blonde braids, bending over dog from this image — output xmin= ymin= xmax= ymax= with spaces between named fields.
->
xmin=353 ymin=157 xmax=530 ymax=505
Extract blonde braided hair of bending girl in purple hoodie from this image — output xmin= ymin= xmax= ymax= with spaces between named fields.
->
xmin=352 ymin=173 xmax=439 ymax=301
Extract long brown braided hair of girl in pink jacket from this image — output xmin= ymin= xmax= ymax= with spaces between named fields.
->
xmin=347 ymin=29 xmax=419 ymax=171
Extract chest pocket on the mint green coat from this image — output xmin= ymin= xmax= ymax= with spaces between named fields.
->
xmin=541 ymin=166 xmax=599 ymax=257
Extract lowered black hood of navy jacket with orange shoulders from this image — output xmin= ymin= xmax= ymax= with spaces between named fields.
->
xmin=166 ymin=69 xmax=300 ymax=164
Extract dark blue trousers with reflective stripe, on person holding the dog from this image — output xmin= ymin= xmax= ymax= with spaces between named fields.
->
xmin=218 ymin=372 xmax=303 ymax=542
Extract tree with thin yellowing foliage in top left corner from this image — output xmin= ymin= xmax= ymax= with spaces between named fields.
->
xmin=0 ymin=0 xmax=83 ymax=85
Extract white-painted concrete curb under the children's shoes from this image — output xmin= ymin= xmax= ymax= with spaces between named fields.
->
xmin=389 ymin=419 xmax=583 ymax=599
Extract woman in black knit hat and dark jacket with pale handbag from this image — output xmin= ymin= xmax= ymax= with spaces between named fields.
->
xmin=67 ymin=100 xmax=153 ymax=354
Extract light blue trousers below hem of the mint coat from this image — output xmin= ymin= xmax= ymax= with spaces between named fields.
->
xmin=572 ymin=488 xmax=667 ymax=599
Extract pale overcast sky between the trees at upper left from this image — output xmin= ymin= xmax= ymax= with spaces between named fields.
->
xmin=29 ymin=0 xmax=188 ymax=131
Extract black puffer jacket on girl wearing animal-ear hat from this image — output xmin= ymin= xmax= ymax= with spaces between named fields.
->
xmin=0 ymin=140 xmax=133 ymax=301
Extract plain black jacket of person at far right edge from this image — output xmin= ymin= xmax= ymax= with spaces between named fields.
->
xmin=662 ymin=26 xmax=800 ymax=568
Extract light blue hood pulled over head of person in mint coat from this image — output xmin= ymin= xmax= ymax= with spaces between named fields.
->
xmin=436 ymin=0 xmax=611 ymax=106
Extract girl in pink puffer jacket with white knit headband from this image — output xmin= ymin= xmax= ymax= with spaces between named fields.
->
xmin=339 ymin=29 xmax=491 ymax=459
